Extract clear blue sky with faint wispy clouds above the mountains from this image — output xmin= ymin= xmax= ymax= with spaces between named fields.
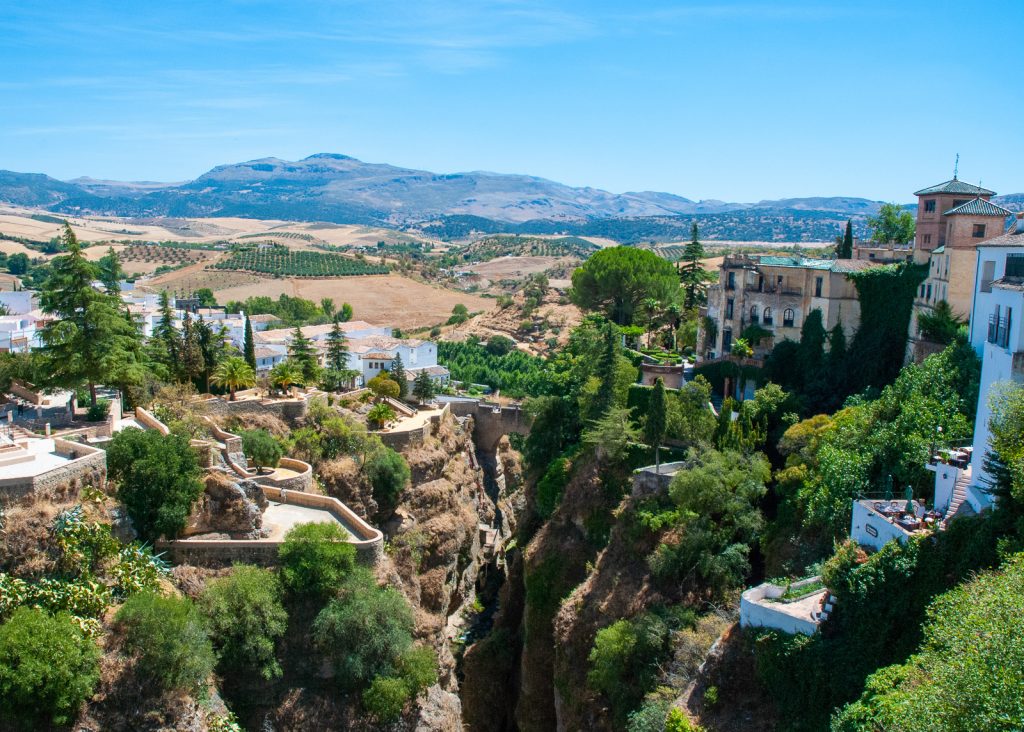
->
xmin=0 ymin=0 xmax=1024 ymax=201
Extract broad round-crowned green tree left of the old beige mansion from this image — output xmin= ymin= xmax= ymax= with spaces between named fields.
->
xmin=569 ymin=247 xmax=679 ymax=326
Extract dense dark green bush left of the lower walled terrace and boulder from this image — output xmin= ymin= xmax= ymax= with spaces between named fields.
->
xmin=106 ymin=430 xmax=203 ymax=543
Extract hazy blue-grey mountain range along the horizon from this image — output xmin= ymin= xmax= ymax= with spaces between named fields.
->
xmin=0 ymin=154 xmax=1024 ymax=241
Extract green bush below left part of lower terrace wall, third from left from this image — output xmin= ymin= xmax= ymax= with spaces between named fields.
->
xmin=200 ymin=564 xmax=288 ymax=680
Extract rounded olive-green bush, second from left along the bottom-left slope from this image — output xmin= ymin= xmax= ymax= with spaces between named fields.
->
xmin=115 ymin=592 xmax=215 ymax=692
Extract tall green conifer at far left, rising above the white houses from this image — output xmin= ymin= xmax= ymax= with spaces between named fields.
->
xmin=40 ymin=224 xmax=142 ymax=404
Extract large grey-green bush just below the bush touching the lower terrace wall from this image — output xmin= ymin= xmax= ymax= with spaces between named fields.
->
xmin=312 ymin=567 xmax=413 ymax=693
